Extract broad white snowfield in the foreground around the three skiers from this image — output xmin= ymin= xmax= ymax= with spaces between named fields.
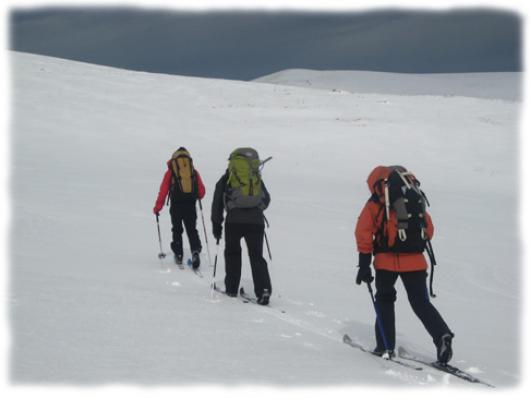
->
xmin=9 ymin=52 xmax=521 ymax=389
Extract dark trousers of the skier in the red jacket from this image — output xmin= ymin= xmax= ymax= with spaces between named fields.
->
xmin=169 ymin=202 xmax=202 ymax=255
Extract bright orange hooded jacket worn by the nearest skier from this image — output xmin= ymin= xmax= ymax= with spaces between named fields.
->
xmin=355 ymin=166 xmax=434 ymax=272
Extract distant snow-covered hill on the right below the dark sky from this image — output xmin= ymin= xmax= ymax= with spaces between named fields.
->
xmin=254 ymin=69 xmax=522 ymax=101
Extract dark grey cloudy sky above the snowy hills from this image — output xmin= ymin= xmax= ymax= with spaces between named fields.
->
xmin=10 ymin=8 xmax=522 ymax=80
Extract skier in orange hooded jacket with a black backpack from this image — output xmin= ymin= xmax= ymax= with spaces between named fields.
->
xmin=355 ymin=166 xmax=454 ymax=363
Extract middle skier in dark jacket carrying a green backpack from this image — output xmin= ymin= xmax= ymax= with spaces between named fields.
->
xmin=211 ymin=148 xmax=272 ymax=305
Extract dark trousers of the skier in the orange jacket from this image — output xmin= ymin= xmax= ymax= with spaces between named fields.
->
xmin=375 ymin=270 xmax=450 ymax=350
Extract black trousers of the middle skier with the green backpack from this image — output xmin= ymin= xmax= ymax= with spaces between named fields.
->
xmin=225 ymin=223 xmax=272 ymax=297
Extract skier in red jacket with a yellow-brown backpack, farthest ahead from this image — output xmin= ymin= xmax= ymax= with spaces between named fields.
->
xmin=153 ymin=147 xmax=206 ymax=269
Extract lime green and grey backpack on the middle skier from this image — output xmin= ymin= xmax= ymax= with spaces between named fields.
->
xmin=226 ymin=148 xmax=264 ymax=210
